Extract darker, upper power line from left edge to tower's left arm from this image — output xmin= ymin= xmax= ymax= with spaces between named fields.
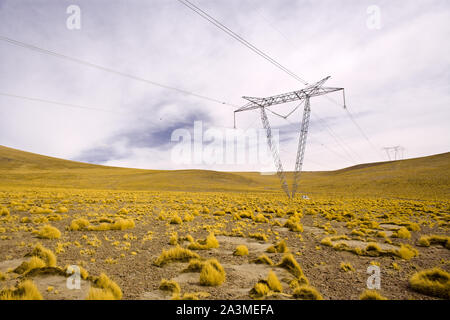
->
xmin=0 ymin=35 xmax=237 ymax=108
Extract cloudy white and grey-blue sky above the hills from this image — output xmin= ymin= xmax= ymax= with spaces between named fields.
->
xmin=0 ymin=0 xmax=450 ymax=171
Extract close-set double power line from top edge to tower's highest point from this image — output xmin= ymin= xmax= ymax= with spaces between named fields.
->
xmin=178 ymin=0 xmax=308 ymax=85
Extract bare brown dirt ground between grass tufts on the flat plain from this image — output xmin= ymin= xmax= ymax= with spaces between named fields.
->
xmin=0 ymin=191 xmax=450 ymax=299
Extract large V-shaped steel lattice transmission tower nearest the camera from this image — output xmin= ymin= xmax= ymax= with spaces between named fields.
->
xmin=234 ymin=77 xmax=345 ymax=198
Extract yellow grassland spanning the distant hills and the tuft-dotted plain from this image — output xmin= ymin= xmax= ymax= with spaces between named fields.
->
xmin=0 ymin=146 xmax=450 ymax=300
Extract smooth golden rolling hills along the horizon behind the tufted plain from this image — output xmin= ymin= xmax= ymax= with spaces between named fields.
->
xmin=0 ymin=146 xmax=450 ymax=199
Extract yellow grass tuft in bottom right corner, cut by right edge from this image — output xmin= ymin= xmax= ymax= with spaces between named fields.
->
xmin=409 ymin=268 xmax=450 ymax=299
